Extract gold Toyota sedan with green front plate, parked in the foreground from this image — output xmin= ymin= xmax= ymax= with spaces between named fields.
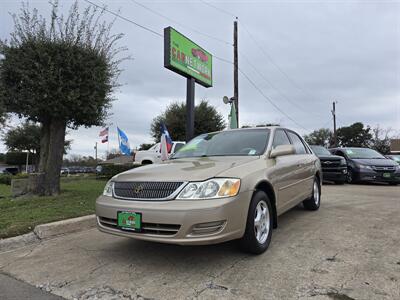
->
xmin=96 ymin=127 xmax=322 ymax=254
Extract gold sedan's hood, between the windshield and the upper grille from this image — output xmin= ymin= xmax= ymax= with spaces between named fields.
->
xmin=114 ymin=156 xmax=260 ymax=181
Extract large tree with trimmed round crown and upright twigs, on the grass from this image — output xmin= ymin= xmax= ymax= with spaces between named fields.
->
xmin=0 ymin=2 xmax=123 ymax=195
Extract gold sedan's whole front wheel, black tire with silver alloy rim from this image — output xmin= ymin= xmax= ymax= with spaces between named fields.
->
xmin=240 ymin=191 xmax=274 ymax=254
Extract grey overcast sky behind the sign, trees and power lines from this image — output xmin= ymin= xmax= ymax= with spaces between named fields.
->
xmin=0 ymin=0 xmax=400 ymax=155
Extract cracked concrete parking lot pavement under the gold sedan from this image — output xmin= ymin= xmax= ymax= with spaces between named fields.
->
xmin=0 ymin=185 xmax=400 ymax=300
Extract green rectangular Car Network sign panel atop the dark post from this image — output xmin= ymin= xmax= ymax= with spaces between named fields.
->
xmin=164 ymin=27 xmax=212 ymax=87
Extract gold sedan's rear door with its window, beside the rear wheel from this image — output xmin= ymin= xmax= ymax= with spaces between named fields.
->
xmin=287 ymin=130 xmax=316 ymax=204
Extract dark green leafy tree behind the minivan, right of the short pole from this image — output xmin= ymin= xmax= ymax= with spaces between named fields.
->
xmin=337 ymin=122 xmax=372 ymax=147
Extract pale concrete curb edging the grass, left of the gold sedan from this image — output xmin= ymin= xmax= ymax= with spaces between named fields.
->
xmin=0 ymin=215 xmax=96 ymax=253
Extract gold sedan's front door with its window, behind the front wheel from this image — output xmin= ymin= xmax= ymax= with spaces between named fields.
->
xmin=271 ymin=128 xmax=298 ymax=214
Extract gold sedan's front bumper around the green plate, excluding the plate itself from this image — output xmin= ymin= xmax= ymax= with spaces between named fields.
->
xmin=96 ymin=191 xmax=252 ymax=245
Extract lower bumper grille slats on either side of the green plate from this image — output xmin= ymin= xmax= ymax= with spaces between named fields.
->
xmin=99 ymin=217 xmax=181 ymax=236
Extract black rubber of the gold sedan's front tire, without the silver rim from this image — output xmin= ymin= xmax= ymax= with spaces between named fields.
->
xmin=240 ymin=191 xmax=274 ymax=254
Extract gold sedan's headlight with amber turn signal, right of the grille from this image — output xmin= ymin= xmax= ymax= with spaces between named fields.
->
xmin=177 ymin=178 xmax=240 ymax=200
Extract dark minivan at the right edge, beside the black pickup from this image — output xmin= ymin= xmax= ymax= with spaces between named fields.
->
xmin=329 ymin=147 xmax=400 ymax=185
